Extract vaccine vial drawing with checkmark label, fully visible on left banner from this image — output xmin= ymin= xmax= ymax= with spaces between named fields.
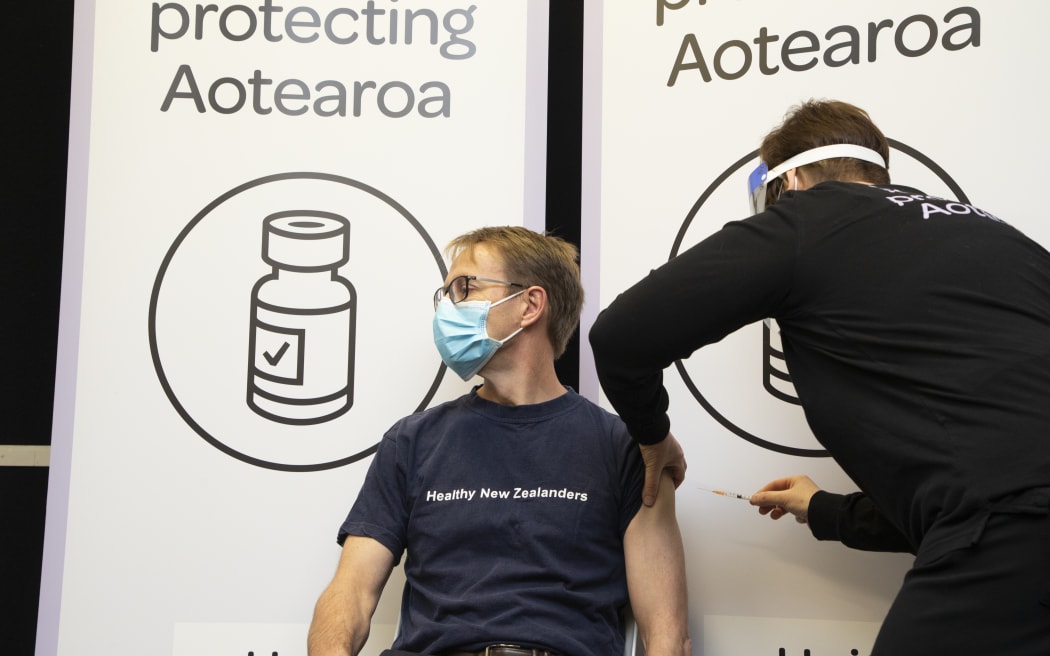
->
xmin=248 ymin=210 xmax=357 ymax=424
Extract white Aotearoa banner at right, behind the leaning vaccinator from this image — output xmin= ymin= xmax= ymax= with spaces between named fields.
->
xmin=581 ymin=0 xmax=1050 ymax=656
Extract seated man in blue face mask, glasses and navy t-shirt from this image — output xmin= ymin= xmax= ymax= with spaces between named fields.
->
xmin=309 ymin=227 xmax=690 ymax=656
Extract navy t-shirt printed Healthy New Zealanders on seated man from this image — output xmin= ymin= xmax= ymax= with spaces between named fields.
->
xmin=339 ymin=389 xmax=644 ymax=656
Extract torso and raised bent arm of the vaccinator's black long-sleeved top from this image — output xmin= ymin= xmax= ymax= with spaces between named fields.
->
xmin=590 ymin=183 xmax=1050 ymax=551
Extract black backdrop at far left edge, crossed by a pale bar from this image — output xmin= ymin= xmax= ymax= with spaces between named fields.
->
xmin=0 ymin=0 xmax=72 ymax=656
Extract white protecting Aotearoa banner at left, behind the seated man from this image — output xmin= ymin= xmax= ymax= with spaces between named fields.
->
xmin=37 ymin=0 xmax=547 ymax=656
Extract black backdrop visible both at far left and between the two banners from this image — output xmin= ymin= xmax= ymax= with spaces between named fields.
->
xmin=0 ymin=0 xmax=584 ymax=656
